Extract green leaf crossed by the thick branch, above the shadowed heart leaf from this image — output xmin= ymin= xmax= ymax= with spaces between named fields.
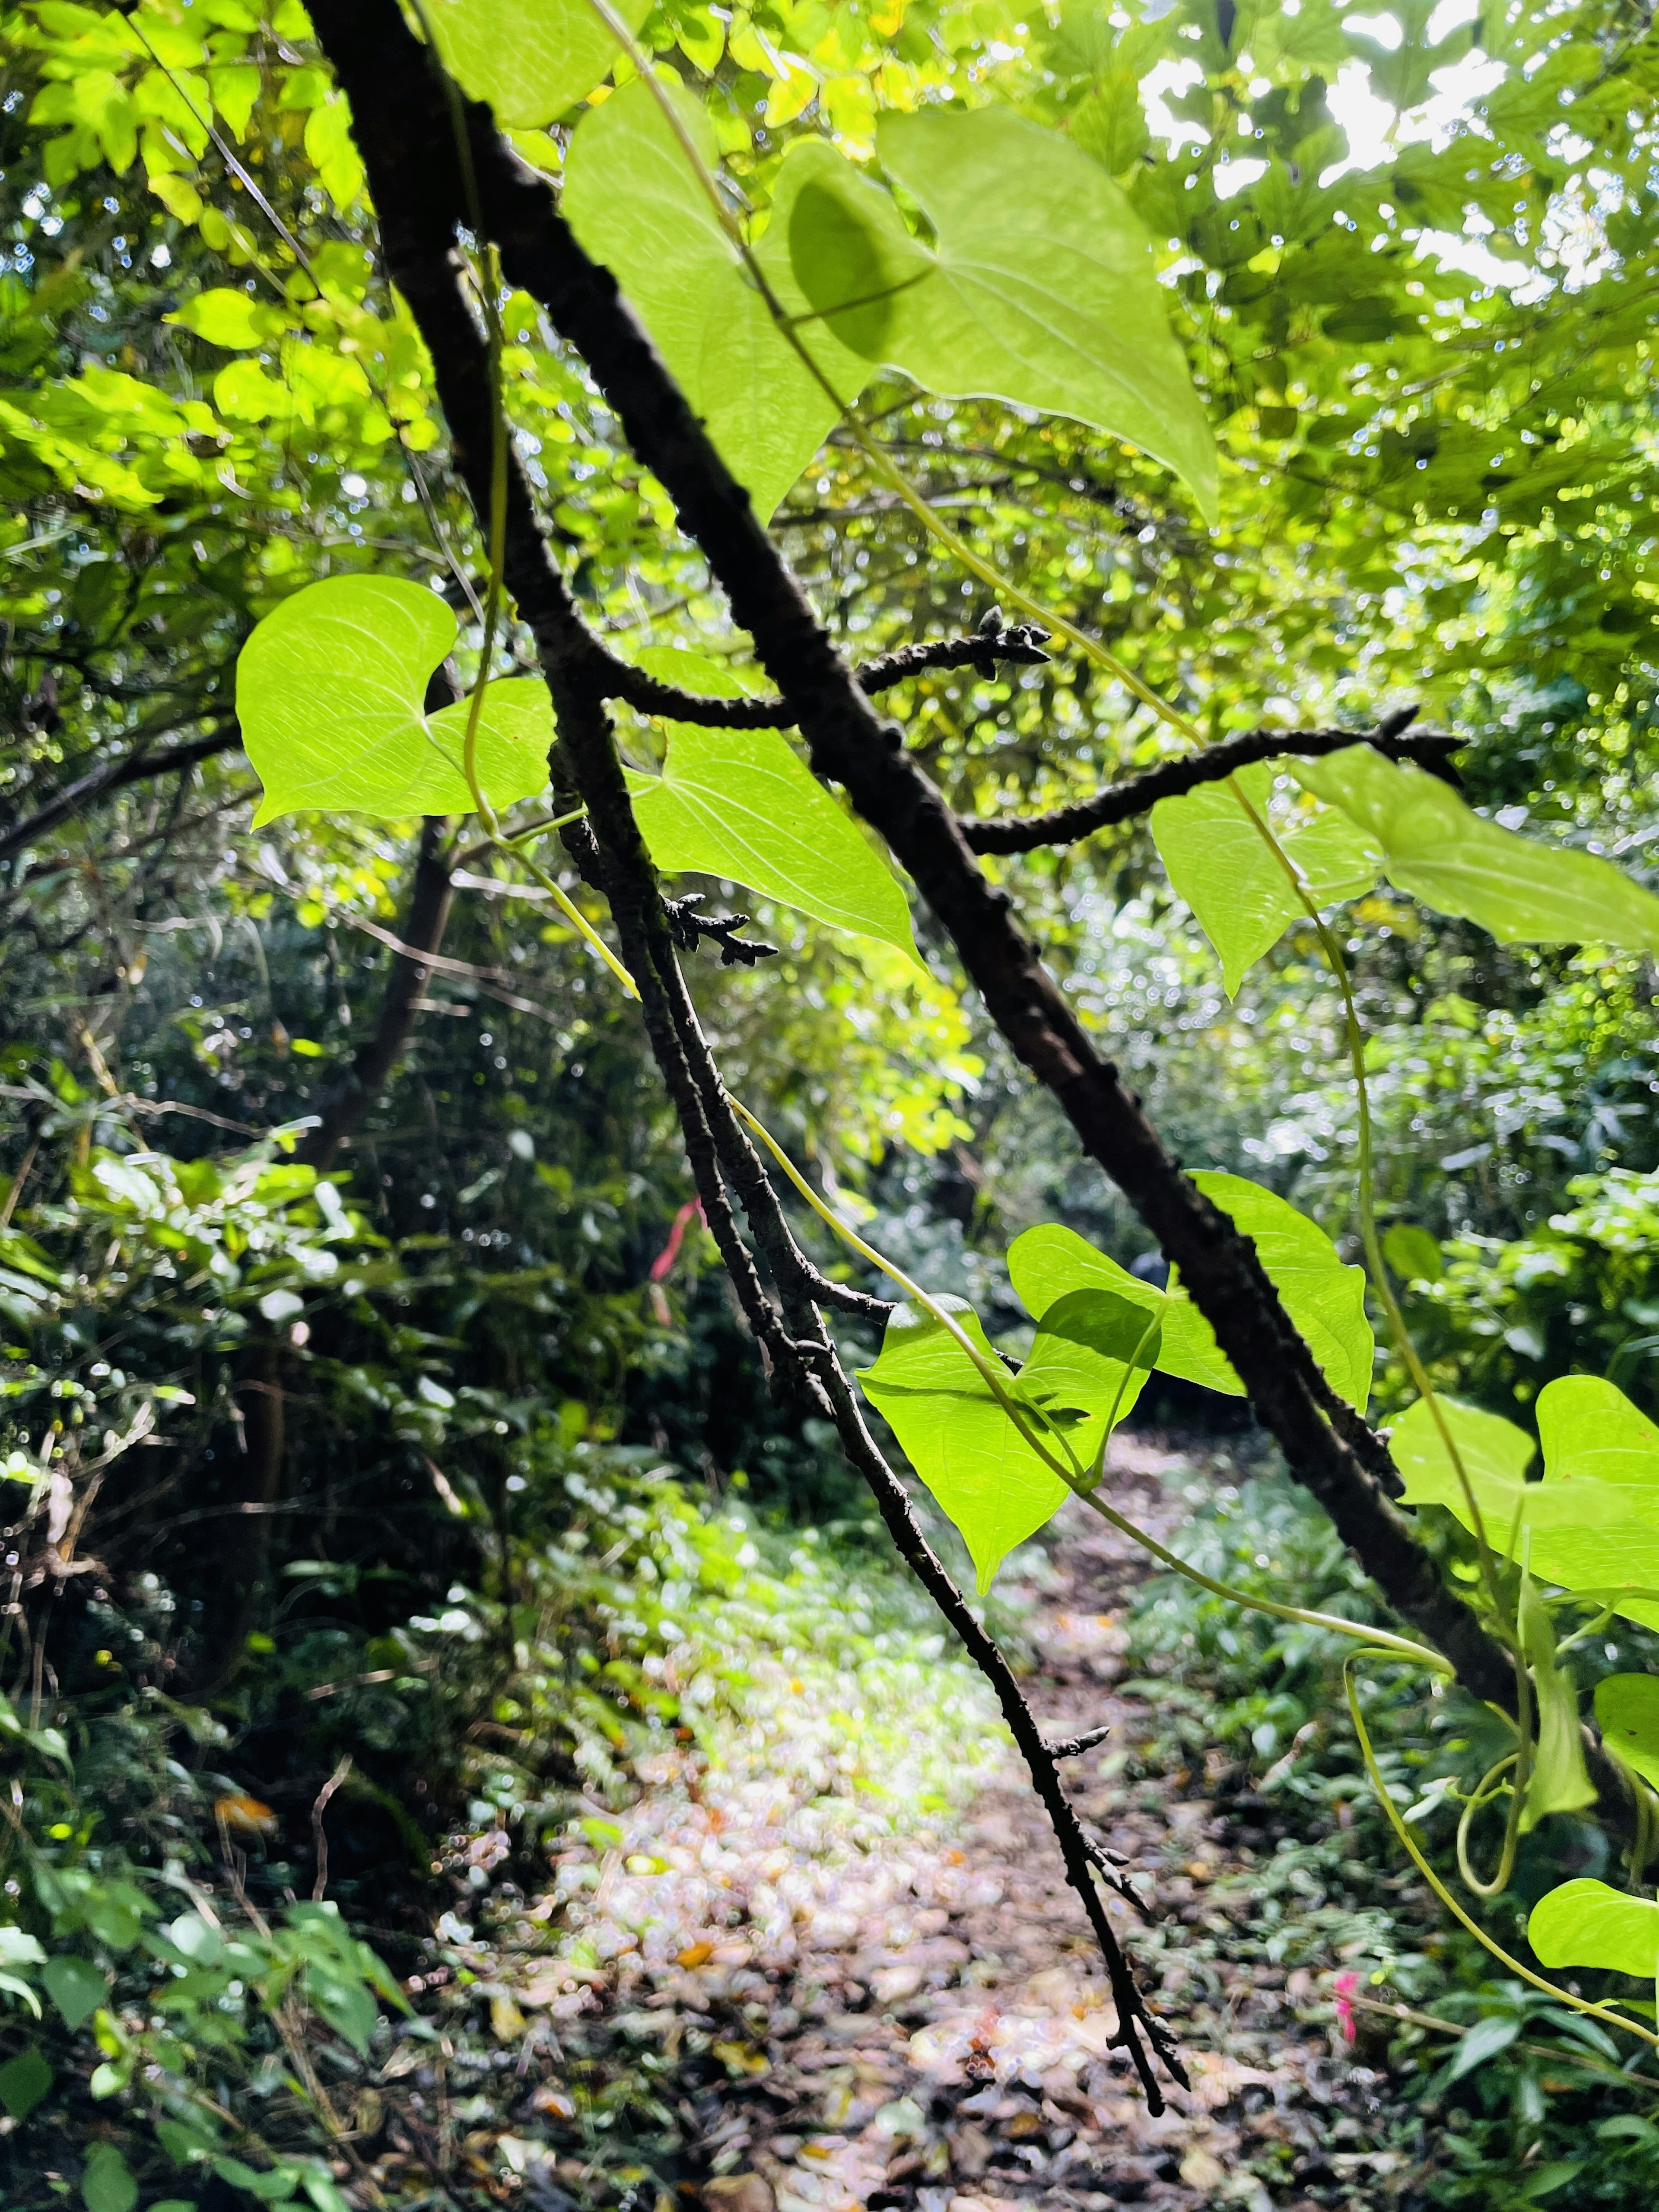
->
xmin=1009 ymin=1168 xmax=1376 ymax=1411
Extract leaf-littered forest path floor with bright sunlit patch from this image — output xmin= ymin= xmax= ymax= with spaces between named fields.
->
xmin=358 ymin=1442 xmax=1407 ymax=2212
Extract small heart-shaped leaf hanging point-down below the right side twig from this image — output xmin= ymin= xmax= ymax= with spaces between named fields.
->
xmin=1153 ymin=761 xmax=1382 ymax=998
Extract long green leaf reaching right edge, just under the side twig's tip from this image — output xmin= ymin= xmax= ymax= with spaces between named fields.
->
xmin=1290 ymin=745 xmax=1659 ymax=951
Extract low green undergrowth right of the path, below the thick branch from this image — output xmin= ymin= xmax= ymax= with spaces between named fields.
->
xmin=1122 ymin=1460 xmax=1659 ymax=2212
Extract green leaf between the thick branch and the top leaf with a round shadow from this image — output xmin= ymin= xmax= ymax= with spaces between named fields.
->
xmin=564 ymin=77 xmax=869 ymax=520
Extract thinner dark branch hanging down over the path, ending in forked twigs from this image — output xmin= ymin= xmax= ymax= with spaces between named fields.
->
xmin=316 ymin=0 xmax=1185 ymax=2110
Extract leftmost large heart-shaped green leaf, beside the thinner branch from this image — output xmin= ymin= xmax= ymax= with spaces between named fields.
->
xmin=237 ymin=575 xmax=553 ymax=825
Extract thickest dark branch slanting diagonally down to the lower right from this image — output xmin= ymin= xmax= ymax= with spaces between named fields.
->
xmin=338 ymin=30 xmax=1513 ymax=1703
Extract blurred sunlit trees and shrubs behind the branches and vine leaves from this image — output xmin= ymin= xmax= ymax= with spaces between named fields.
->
xmin=0 ymin=0 xmax=1659 ymax=2212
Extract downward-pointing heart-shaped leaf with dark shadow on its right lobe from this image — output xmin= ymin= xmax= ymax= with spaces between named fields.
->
xmin=858 ymin=1290 xmax=1157 ymax=1590
